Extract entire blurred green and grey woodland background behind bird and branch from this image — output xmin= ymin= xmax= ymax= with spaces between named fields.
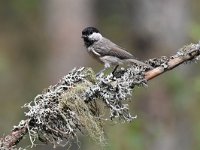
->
xmin=0 ymin=0 xmax=200 ymax=150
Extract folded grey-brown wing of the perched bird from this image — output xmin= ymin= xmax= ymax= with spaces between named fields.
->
xmin=95 ymin=39 xmax=134 ymax=59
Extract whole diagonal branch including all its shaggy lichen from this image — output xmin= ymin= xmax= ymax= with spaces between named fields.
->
xmin=0 ymin=43 xmax=200 ymax=149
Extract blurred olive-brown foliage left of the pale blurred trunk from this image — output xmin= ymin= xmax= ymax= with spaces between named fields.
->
xmin=0 ymin=0 xmax=47 ymax=141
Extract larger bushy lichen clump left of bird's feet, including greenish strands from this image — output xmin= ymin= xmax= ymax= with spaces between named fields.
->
xmin=21 ymin=68 xmax=103 ymax=147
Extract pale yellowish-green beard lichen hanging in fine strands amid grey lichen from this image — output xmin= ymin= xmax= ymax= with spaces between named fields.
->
xmin=59 ymin=83 xmax=105 ymax=145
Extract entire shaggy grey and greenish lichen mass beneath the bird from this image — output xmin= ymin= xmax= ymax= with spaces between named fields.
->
xmin=12 ymin=66 xmax=146 ymax=147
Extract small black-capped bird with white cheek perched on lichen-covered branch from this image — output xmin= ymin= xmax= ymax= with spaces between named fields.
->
xmin=82 ymin=27 xmax=152 ymax=75
